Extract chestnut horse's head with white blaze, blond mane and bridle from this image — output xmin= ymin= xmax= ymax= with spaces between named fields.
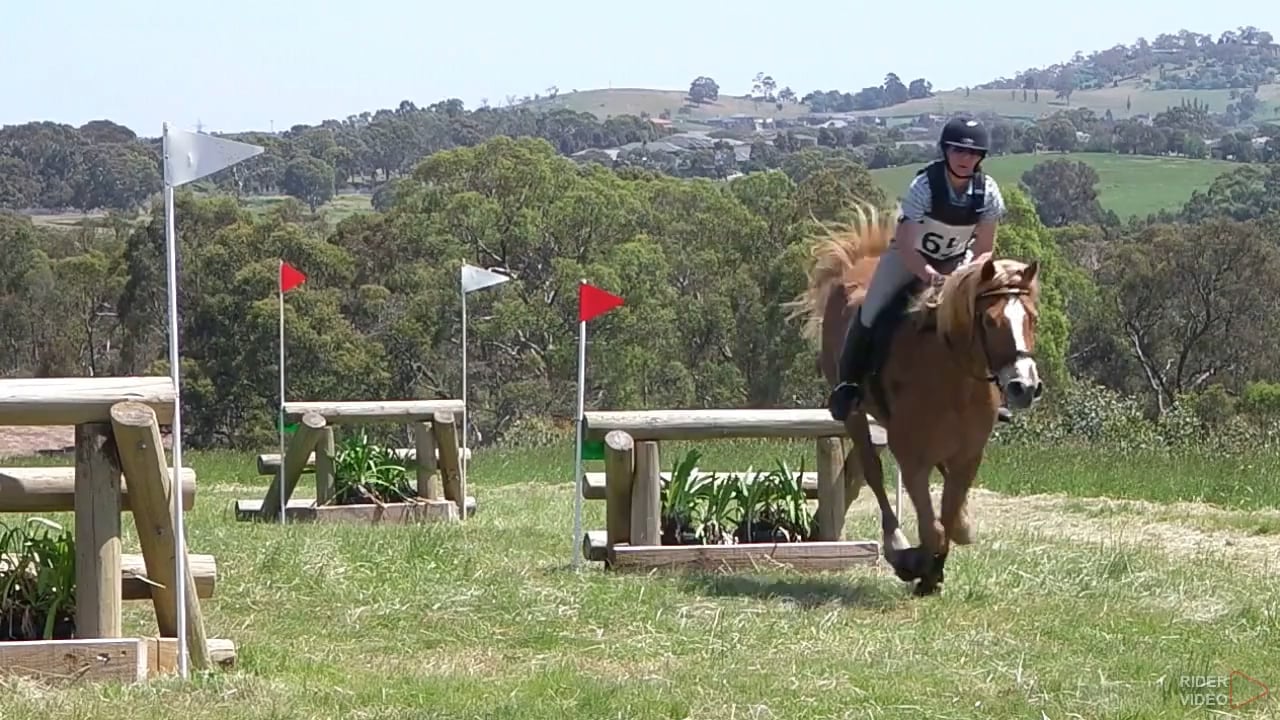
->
xmin=927 ymin=254 xmax=1044 ymax=410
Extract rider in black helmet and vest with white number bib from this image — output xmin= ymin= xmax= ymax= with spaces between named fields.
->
xmin=828 ymin=118 xmax=1009 ymax=421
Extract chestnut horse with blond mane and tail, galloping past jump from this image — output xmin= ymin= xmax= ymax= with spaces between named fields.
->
xmin=787 ymin=208 xmax=1043 ymax=596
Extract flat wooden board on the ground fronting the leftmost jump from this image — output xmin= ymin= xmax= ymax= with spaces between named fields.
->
xmin=0 ymin=638 xmax=147 ymax=683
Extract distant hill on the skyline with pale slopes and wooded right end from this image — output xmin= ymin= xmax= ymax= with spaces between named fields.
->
xmin=519 ymin=26 xmax=1280 ymax=124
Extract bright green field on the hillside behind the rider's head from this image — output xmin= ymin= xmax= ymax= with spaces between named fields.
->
xmin=872 ymin=152 xmax=1240 ymax=219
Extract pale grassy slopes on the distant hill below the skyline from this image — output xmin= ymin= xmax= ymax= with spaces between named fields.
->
xmin=530 ymin=81 xmax=1280 ymax=120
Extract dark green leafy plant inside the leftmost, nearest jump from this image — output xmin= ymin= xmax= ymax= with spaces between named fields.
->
xmin=0 ymin=518 xmax=76 ymax=641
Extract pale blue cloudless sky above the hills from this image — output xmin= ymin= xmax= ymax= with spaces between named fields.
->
xmin=0 ymin=0 xmax=1280 ymax=136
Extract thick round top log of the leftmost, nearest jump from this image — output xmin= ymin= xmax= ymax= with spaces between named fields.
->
xmin=0 ymin=377 xmax=177 ymax=425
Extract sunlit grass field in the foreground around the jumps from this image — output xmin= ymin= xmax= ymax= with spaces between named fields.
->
xmin=0 ymin=442 xmax=1280 ymax=720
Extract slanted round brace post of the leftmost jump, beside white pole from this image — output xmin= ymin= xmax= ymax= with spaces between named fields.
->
xmin=111 ymin=401 xmax=209 ymax=670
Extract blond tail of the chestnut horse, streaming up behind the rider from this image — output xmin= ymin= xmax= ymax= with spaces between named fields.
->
xmin=785 ymin=204 xmax=899 ymax=341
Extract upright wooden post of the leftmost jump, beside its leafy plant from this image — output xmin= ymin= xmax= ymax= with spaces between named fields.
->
xmin=73 ymin=423 xmax=124 ymax=638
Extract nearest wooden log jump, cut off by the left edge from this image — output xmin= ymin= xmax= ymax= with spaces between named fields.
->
xmin=0 ymin=377 xmax=236 ymax=682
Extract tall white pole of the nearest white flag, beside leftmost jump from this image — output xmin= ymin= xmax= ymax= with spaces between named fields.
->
xmin=163 ymin=123 xmax=189 ymax=679
